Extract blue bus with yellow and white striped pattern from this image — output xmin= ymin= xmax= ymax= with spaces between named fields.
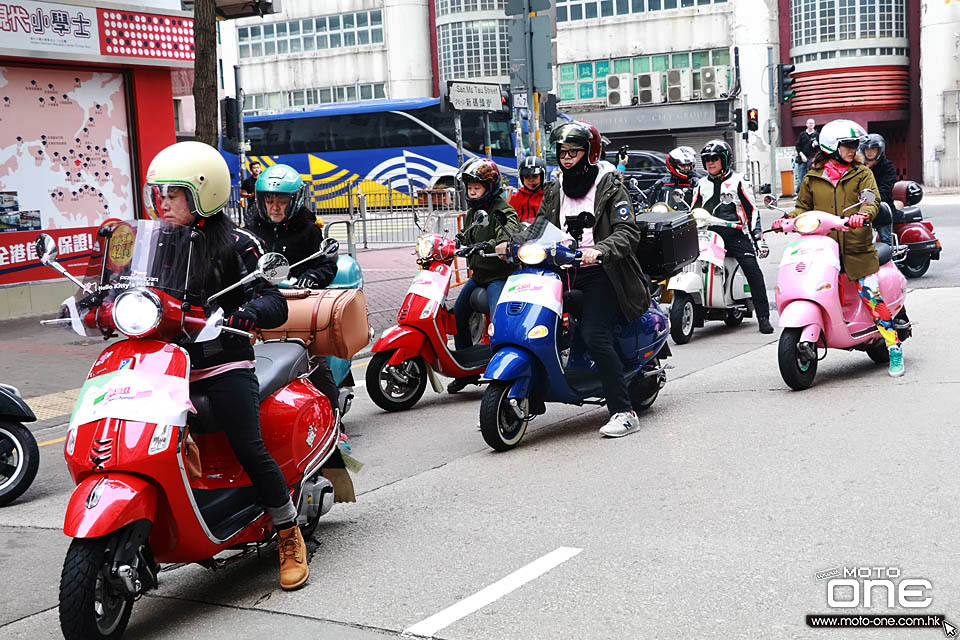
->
xmin=222 ymin=98 xmax=517 ymax=211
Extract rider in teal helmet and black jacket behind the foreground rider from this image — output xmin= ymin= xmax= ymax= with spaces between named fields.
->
xmin=247 ymin=164 xmax=340 ymax=409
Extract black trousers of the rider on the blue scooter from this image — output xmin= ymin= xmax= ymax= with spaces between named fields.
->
xmin=561 ymin=265 xmax=633 ymax=415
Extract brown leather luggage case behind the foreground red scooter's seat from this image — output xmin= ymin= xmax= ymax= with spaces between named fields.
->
xmin=260 ymin=289 xmax=370 ymax=360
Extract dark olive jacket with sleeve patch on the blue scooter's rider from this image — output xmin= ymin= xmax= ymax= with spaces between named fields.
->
xmin=537 ymin=172 xmax=650 ymax=320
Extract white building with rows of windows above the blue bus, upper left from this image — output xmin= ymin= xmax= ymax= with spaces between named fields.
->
xmin=220 ymin=0 xmax=434 ymax=114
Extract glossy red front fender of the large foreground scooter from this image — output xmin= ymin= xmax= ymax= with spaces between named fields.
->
xmin=63 ymin=473 xmax=159 ymax=538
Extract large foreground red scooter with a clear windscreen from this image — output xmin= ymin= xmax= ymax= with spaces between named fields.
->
xmin=37 ymin=220 xmax=340 ymax=640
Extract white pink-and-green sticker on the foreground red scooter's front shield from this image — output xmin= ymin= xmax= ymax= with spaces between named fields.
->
xmin=70 ymin=369 xmax=193 ymax=429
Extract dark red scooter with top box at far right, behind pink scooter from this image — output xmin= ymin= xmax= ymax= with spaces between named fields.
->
xmin=892 ymin=180 xmax=942 ymax=278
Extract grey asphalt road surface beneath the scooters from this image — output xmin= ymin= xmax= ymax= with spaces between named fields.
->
xmin=0 ymin=198 xmax=960 ymax=640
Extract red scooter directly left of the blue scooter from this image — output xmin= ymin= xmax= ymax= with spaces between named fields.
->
xmin=366 ymin=212 xmax=491 ymax=411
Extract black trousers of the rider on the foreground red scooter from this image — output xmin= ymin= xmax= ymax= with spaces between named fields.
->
xmin=190 ymin=369 xmax=290 ymax=510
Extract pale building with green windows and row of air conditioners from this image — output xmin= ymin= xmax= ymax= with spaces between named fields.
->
xmin=555 ymin=0 xmax=778 ymax=183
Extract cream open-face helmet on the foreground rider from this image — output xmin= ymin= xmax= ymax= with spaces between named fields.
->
xmin=143 ymin=142 xmax=230 ymax=220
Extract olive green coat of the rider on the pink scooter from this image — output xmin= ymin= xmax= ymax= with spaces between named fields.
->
xmin=790 ymin=165 xmax=880 ymax=280
